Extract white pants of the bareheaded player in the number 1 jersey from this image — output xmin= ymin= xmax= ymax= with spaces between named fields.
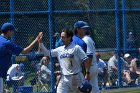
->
xmin=57 ymin=72 xmax=85 ymax=93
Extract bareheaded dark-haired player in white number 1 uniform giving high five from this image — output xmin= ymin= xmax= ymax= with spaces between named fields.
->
xmin=39 ymin=29 xmax=90 ymax=93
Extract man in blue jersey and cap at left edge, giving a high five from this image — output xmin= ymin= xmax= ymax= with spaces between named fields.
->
xmin=0 ymin=23 xmax=40 ymax=93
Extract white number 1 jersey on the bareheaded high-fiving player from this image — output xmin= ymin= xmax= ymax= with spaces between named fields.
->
xmin=40 ymin=43 xmax=87 ymax=75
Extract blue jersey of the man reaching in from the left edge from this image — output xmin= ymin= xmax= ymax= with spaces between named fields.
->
xmin=0 ymin=35 xmax=23 ymax=78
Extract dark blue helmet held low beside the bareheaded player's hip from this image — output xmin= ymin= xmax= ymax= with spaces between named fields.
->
xmin=78 ymin=81 xmax=92 ymax=93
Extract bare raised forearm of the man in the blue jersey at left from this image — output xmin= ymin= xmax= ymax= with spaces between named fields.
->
xmin=21 ymin=32 xmax=43 ymax=54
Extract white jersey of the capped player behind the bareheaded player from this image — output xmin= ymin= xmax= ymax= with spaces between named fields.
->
xmin=82 ymin=35 xmax=97 ymax=64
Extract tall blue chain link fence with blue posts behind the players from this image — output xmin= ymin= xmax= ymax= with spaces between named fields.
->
xmin=0 ymin=0 xmax=140 ymax=93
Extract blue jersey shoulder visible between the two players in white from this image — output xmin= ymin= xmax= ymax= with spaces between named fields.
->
xmin=72 ymin=35 xmax=87 ymax=53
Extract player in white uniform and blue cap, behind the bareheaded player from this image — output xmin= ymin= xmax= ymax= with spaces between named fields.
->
xmin=74 ymin=21 xmax=100 ymax=93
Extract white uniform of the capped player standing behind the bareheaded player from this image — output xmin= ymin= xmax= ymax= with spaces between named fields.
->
xmin=82 ymin=35 xmax=100 ymax=93
